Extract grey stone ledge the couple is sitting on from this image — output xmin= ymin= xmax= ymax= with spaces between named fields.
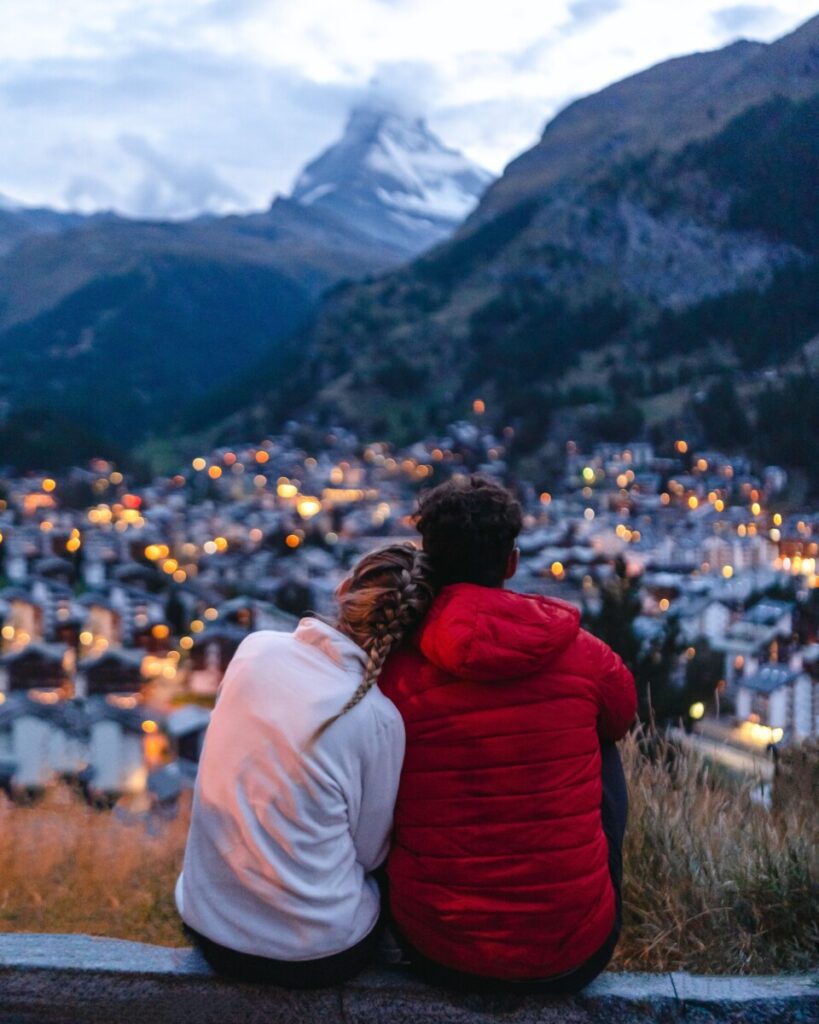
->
xmin=0 ymin=934 xmax=819 ymax=1024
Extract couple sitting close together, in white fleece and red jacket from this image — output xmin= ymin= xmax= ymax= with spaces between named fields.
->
xmin=176 ymin=477 xmax=636 ymax=993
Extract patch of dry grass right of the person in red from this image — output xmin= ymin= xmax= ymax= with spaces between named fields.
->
xmin=615 ymin=736 xmax=819 ymax=974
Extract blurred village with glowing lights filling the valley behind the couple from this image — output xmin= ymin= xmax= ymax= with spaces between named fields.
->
xmin=0 ymin=411 xmax=819 ymax=809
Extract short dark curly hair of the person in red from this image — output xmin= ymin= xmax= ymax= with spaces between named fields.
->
xmin=416 ymin=475 xmax=523 ymax=587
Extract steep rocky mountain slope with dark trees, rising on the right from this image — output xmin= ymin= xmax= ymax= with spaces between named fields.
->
xmin=217 ymin=17 xmax=819 ymax=475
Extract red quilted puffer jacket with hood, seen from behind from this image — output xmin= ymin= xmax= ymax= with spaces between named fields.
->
xmin=379 ymin=584 xmax=636 ymax=979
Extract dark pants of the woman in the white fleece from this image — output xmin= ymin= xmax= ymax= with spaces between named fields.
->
xmin=185 ymin=925 xmax=381 ymax=988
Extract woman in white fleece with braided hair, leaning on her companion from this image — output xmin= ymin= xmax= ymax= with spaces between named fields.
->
xmin=176 ymin=544 xmax=433 ymax=988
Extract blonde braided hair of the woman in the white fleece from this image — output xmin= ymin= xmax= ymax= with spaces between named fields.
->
xmin=312 ymin=544 xmax=435 ymax=739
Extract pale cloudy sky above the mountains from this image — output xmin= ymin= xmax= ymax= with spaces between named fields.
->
xmin=0 ymin=0 xmax=817 ymax=217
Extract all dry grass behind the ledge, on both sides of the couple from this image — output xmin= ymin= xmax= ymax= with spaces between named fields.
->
xmin=0 ymin=738 xmax=819 ymax=974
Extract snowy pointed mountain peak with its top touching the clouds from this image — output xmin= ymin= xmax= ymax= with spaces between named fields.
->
xmin=293 ymin=106 xmax=492 ymax=255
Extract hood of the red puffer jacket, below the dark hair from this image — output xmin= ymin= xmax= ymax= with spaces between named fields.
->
xmin=418 ymin=583 xmax=580 ymax=681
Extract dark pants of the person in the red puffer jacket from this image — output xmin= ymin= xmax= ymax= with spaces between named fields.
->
xmin=391 ymin=742 xmax=629 ymax=995
